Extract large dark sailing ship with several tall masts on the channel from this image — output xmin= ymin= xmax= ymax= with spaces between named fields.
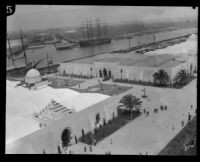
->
xmin=79 ymin=18 xmax=112 ymax=47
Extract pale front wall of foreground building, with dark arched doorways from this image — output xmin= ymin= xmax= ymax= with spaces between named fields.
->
xmin=6 ymin=96 xmax=122 ymax=154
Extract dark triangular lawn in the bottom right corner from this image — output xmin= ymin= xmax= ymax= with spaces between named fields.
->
xmin=158 ymin=117 xmax=197 ymax=155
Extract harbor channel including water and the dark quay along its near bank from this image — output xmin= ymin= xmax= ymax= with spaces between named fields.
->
xmin=7 ymin=28 xmax=197 ymax=78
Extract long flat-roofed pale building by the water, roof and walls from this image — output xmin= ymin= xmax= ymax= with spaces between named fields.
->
xmin=59 ymin=53 xmax=197 ymax=84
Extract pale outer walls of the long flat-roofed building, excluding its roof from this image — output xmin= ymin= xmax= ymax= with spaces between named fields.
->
xmin=60 ymin=56 xmax=197 ymax=83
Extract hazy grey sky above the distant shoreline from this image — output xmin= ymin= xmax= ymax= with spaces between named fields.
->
xmin=7 ymin=5 xmax=198 ymax=31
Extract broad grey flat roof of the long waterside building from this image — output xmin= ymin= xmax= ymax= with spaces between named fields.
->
xmin=65 ymin=53 xmax=183 ymax=68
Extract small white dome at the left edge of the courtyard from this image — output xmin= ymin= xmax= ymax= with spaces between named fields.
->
xmin=25 ymin=69 xmax=42 ymax=84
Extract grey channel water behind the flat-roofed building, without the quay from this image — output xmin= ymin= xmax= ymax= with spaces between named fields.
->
xmin=7 ymin=28 xmax=197 ymax=67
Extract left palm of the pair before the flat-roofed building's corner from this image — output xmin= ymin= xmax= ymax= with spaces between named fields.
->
xmin=153 ymin=69 xmax=169 ymax=86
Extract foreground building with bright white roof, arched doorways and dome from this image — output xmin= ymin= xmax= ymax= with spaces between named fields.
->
xmin=6 ymin=69 xmax=115 ymax=154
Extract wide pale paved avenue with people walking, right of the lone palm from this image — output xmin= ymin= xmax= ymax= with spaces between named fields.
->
xmin=66 ymin=80 xmax=197 ymax=155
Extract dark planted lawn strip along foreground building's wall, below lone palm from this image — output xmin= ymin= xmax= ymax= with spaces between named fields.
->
xmin=79 ymin=110 xmax=141 ymax=144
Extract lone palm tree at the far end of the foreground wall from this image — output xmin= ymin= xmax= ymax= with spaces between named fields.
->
xmin=119 ymin=94 xmax=142 ymax=119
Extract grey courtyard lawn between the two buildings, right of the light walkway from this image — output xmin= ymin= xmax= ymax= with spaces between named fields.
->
xmin=70 ymin=84 xmax=132 ymax=96
